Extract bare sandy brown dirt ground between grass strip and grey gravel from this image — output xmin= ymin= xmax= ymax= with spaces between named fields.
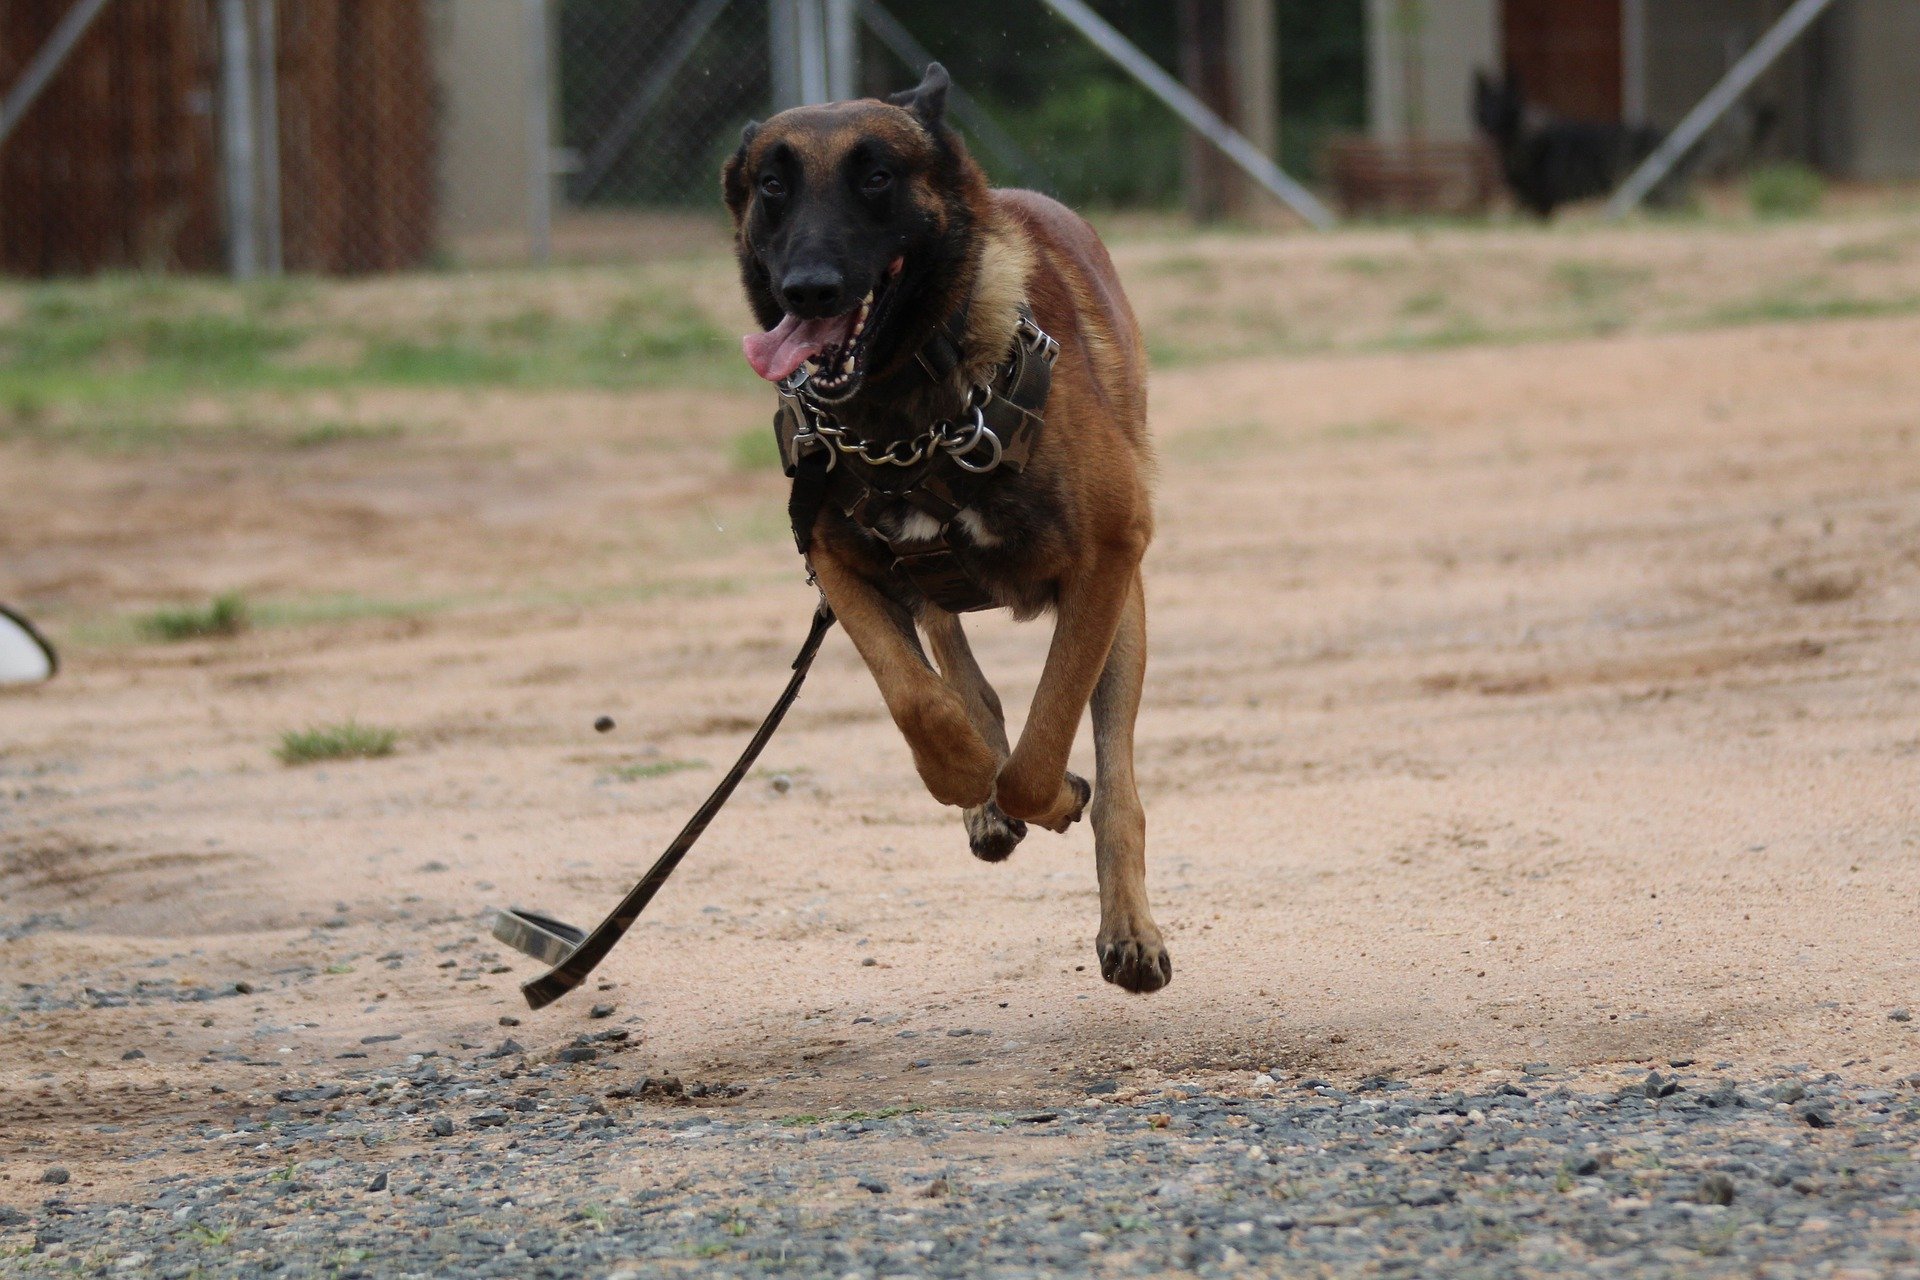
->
xmin=0 ymin=219 xmax=1920 ymax=1203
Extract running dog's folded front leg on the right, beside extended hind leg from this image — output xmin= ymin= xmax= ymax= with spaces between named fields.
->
xmin=995 ymin=547 xmax=1140 ymax=831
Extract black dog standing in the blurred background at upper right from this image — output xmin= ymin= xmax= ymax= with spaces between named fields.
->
xmin=1473 ymin=71 xmax=1674 ymax=219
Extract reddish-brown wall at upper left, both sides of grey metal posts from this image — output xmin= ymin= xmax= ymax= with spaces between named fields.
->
xmin=0 ymin=0 xmax=436 ymax=276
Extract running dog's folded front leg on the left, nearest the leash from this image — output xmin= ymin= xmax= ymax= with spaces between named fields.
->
xmin=812 ymin=543 xmax=998 ymax=808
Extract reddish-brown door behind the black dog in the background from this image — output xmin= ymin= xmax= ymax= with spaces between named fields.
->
xmin=1501 ymin=0 xmax=1622 ymax=123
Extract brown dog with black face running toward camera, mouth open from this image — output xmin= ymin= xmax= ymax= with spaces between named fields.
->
xmin=722 ymin=63 xmax=1173 ymax=992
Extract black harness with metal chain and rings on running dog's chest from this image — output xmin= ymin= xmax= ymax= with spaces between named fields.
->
xmin=774 ymin=305 xmax=1060 ymax=614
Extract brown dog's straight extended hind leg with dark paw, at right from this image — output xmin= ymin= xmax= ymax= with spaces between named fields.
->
xmin=1092 ymin=572 xmax=1173 ymax=992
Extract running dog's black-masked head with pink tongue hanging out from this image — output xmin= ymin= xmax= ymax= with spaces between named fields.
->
xmin=722 ymin=63 xmax=985 ymax=401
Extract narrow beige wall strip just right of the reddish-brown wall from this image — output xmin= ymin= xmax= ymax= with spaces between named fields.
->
xmin=432 ymin=0 xmax=551 ymax=238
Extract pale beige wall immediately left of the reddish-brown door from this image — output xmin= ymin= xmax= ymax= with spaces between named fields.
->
xmin=1367 ymin=0 xmax=1501 ymax=142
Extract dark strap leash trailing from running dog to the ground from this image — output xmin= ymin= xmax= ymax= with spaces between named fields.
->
xmin=493 ymin=599 xmax=833 ymax=1009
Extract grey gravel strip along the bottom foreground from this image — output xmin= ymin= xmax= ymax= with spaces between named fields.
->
xmin=0 ymin=1055 xmax=1920 ymax=1280
